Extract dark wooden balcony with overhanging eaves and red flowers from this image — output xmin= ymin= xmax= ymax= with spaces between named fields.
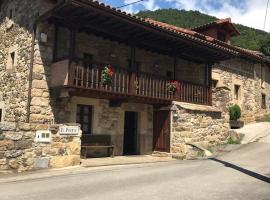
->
xmin=40 ymin=0 xmax=235 ymax=105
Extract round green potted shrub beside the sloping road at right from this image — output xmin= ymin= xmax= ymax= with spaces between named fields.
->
xmin=229 ymin=104 xmax=244 ymax=129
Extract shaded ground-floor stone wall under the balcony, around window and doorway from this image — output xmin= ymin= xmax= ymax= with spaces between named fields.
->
xmin=54 ymin=96 xmax=153 ymax=156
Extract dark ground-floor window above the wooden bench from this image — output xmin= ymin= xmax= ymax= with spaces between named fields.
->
xmin=76 ymin=105 xmax=93 ymax=134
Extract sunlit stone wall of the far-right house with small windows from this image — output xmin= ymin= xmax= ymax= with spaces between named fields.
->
xmin=212 ymin=59 xmax=270 ymax=123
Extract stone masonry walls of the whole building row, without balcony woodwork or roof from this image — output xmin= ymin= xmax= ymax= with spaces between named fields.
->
xmin=0 ymin=0 xmax=270 ymax=172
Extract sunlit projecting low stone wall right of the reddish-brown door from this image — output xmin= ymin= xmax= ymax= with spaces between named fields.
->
xmin=171 ymin=102 xmax=229 ymax=159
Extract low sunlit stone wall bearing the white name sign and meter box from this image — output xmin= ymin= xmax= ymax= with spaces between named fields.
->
xmin=0 ymin=123 xmax=81 ymax=172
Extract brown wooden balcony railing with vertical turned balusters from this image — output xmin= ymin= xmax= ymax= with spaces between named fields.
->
xmin=68 ymin=64 xmax=212 ymax=105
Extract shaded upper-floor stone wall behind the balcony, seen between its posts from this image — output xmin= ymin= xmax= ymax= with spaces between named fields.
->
xmin=76 ymin=33 xmax=205 ymax=84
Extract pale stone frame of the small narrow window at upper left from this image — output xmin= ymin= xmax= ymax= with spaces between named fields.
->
xmin=6 ymin=45 xmax=18 ymax=73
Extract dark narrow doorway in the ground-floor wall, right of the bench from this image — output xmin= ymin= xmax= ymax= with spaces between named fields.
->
xmin=123 ymin=112 xmax=137 ymax=155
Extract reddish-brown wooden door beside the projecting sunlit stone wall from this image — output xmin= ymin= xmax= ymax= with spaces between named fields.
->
xmin=153 ymin=111 xmax=171 ymax=152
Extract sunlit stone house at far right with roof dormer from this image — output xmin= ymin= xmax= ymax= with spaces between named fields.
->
xmin=192 ymin=18 xmax=270 ymax=123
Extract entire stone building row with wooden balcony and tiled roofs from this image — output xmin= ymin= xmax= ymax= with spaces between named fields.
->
xmin=0 ymin=0 xmax=270 ymax=171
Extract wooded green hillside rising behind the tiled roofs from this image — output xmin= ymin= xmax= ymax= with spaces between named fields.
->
xmin=137 ymin=9 xmax=270 ymax=56
